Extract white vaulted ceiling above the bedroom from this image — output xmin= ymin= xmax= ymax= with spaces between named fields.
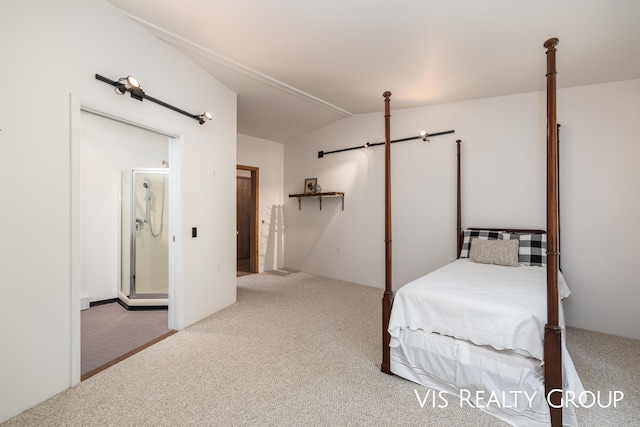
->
xmin=109 ymin=0 xmax=640 ymax=142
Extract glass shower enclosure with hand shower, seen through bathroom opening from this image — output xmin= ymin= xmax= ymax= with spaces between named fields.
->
xmin=118 ymin=168 xmax=169 ymax=309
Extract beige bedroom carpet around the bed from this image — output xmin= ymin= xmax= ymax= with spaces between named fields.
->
xmin=3 ymin=272 xmax=640 ymax=427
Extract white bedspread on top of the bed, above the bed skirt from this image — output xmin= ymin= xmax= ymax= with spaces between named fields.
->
xmin=389 ymin=259 xmax=570 ymax=361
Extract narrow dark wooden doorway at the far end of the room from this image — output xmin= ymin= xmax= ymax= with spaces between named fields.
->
xmin=236 ymin=165 xmax=259 ymax=276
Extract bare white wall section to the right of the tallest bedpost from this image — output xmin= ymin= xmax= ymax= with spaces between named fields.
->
xmin=558 ymin=80 xmax=640 ymax=339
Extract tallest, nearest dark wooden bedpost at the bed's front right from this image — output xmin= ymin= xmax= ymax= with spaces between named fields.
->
xmin=544 ymin=38 xmax=563 ymax=427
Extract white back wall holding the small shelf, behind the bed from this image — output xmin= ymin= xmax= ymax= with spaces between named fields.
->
xmin=285 ymin=90 xmax=545 ymax=288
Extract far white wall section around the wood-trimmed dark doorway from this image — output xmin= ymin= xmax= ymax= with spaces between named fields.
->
xmin=238 ymin=134 xmax=284 ymax=272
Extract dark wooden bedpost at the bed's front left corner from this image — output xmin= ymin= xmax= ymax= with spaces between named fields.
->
xmin=381 ymin=91 xmax=393 ymax=374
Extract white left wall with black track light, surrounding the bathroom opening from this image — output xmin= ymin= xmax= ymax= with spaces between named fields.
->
xmin=0 ymin=0 xmax=236 ymax=420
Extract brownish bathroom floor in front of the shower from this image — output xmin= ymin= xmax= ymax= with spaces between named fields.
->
xmin=80 ymin=302 xmax=175 ymax=380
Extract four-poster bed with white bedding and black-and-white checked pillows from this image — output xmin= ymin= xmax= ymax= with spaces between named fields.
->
xmin=382 ymin=38 xmax=584 ymax=427
